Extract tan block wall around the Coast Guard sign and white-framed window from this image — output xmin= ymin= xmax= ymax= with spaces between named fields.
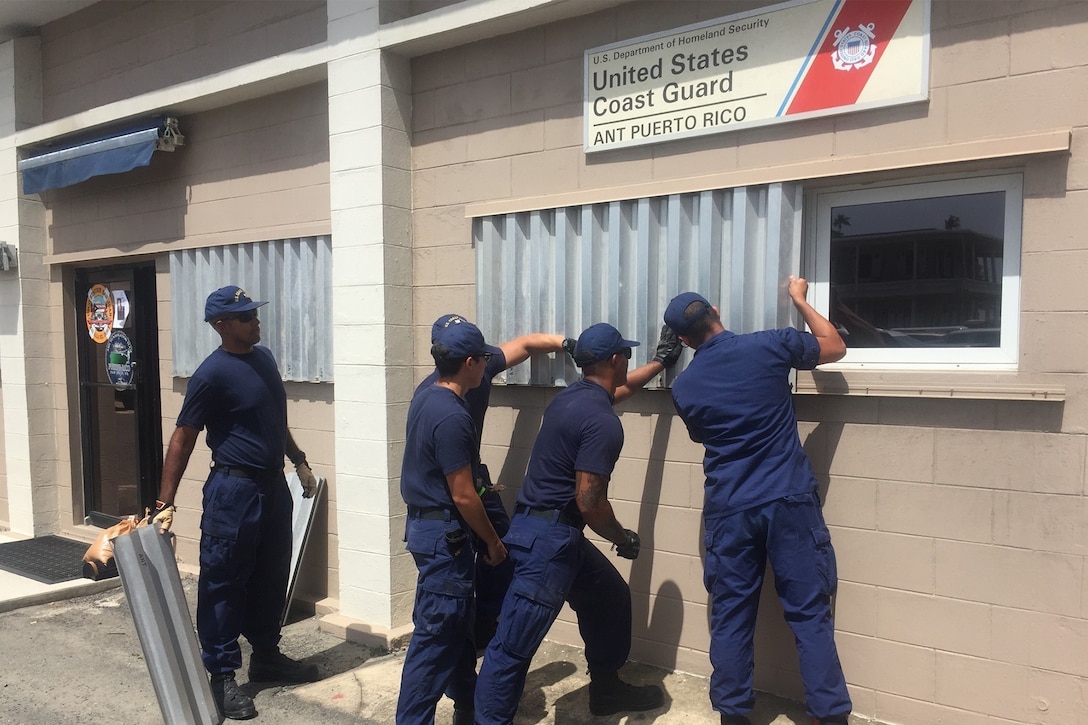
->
xmin=412 ymin=0 xmax=1088 ymax=723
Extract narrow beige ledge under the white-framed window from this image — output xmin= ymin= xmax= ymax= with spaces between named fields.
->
xmin=794 ymin=370 xmax=1065 ymax=403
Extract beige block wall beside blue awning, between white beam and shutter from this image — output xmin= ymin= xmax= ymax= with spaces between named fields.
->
xmin=42 ymin=83 xmax=331 ymax=258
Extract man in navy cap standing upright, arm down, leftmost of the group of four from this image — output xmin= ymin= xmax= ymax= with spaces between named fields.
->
xmin=397 ymin=318 xmax=506 ymax=725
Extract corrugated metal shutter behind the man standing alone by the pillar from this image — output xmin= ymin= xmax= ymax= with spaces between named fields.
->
xmin=170 ymin=236 xmax=333 ymax=382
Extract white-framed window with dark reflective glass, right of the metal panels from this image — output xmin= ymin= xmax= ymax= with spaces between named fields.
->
xmin=809 ymin=174 xmax=1024 ymax=369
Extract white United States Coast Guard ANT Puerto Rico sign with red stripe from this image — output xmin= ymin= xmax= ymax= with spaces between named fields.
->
xmin=583 ymin=0 xmax=929 ymax=152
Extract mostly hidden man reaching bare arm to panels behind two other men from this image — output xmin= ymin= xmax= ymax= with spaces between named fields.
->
xmin=416 ymin=314 xmax=574 ymax=651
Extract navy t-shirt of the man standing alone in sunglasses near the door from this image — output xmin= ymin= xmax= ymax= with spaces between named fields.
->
xmin=177 ymin=345 xmax=287 ymax=469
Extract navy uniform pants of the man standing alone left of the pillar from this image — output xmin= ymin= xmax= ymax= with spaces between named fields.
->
xmin=197 ymin=470 xmax=292 ymax=674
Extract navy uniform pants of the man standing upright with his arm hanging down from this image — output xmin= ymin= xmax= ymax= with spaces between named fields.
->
xmin=397 ymin=516 xmax=475 ymax=725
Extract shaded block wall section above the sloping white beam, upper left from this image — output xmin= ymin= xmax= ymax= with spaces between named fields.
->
xmin=41 ymin=0 xmax=327 ymax=121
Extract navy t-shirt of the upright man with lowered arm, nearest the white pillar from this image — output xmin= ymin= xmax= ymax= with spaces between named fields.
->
xmin=400 ymin=384 xmax=480 ymax=508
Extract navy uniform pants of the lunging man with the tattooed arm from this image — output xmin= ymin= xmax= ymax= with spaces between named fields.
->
xmin=475 ymin=514 xmax=631 ymax=725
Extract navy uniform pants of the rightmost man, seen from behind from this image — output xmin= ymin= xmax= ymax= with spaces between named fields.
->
xmin=704 ymin=493 xmax=851 ymax=717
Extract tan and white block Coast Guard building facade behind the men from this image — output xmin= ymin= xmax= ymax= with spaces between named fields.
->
xmin=0 ymin=0 xmax=1088 ymax=724
